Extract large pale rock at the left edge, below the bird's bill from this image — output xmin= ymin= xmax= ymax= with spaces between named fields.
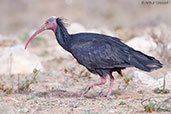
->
xmin=0 ymin=45 xmax=43 ymax=74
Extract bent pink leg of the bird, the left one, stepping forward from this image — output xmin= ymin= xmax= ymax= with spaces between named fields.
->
xmin=84 ymin=76 xmax=106 ymax=94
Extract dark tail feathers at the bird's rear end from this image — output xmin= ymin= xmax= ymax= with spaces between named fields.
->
xmin=129 ymin=50 xmax=163 ymax=72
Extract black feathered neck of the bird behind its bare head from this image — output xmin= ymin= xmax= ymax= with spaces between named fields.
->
xmin=55 ymin=20 xmax=70 ymax=50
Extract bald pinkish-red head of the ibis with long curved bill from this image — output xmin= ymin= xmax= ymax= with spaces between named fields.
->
xmin=25 ymin=16 xmax=57 ymax=49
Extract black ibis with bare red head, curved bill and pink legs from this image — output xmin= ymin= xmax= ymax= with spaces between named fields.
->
xmin=25 ymin=16 xmax=163 ymax=98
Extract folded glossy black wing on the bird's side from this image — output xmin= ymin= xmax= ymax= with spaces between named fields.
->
xmin=70 ymin=35 xmax=130 ymax=69
